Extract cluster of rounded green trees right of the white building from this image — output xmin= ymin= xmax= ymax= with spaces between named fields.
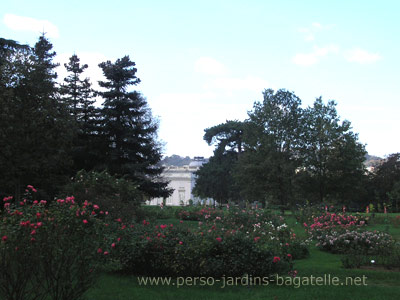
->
xmin=200 ymin=89 xmax=368 ymax=210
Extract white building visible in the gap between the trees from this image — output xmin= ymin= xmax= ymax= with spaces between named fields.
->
xmin=147 ymin=157 xmax=214 ymax=206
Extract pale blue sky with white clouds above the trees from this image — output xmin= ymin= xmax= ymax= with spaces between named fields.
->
xmin=0 ymin=0 xmax=400 ymax=157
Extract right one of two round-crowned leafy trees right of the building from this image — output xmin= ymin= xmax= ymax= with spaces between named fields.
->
xmin=301 ymin=97 xmax=366 ymax=203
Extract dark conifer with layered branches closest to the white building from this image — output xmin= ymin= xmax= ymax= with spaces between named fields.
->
xmin=99 ymin=56 xmax=171 ymax=197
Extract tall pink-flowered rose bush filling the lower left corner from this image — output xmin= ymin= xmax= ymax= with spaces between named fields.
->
xmin=0 ymin=187 xmax=116 ymax=300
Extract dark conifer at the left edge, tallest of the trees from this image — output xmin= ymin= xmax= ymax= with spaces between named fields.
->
xmin=0 ymin=35 xmax=72 ymax=201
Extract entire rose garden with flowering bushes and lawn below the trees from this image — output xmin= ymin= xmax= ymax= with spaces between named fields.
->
xmin=0 ymin=186 xmax=400 ymax=299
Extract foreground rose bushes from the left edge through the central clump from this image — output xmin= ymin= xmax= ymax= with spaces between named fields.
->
xmin=0 ymin=188 xmax=308 ymax=299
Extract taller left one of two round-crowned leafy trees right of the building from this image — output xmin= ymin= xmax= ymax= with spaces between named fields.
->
xmin=236 ymin=89 xmax=302 ymax=207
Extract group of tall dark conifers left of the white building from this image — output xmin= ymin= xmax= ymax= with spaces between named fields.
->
xmin=0 ymin=35 xmax=170 ymax=201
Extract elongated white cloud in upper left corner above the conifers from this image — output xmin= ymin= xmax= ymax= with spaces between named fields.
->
xmin=3 ymin=14 xmax=59 ymax=38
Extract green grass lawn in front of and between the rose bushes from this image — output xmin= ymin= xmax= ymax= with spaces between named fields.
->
xmin=87 ymin=212 xmax=400 ymax=300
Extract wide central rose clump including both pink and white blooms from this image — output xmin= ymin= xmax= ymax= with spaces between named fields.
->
xmin=109 ymin=209 xmax=308 ymax=276
